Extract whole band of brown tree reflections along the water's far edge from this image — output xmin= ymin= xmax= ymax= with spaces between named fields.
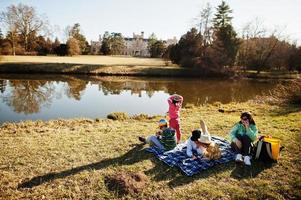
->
xmin=0 ymin=75 xmax=275 ymax=118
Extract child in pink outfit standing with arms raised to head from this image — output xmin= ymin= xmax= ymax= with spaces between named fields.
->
xmin=167 ymin=94 xmax=183 ymax=143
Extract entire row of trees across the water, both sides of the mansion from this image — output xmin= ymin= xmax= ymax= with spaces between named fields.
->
xmin=0 ymin=1 xmax=301 ymax=74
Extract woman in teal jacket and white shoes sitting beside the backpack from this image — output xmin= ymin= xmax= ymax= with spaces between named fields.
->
xmin=230 ymin=112 xmax=258 ymax=166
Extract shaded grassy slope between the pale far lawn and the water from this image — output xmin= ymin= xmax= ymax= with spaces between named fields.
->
xmin=0 ymin=62 xmax=300 ymax=80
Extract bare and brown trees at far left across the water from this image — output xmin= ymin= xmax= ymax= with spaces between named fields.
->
xmin=0 ymin=4 xmax=90 ymax=56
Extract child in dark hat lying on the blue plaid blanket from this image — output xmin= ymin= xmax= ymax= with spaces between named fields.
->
xmin=186 ymin=120 xmax=221 ymax=160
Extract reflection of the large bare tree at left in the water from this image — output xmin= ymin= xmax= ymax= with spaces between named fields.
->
xmin=4 ymin=80 xmax=55 ymax=114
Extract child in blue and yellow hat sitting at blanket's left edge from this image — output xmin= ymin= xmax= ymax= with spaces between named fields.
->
xmin=139 ymin=119 xmax=176 ymax=151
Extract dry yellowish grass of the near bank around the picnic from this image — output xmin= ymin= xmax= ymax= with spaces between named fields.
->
xmin=0 ymin=102 xmax=301 ymax=199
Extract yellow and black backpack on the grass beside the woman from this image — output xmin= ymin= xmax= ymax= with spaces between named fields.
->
xmin=253 ymin=136 xmax=283 ymax=162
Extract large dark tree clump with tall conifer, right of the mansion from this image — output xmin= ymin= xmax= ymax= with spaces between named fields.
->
xmin=167 ymin=1 xmax=301 ymax=74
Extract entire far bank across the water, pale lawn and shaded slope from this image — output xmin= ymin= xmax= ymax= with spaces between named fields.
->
xmin=0 ymin=56 xmax=299 ymax=79
